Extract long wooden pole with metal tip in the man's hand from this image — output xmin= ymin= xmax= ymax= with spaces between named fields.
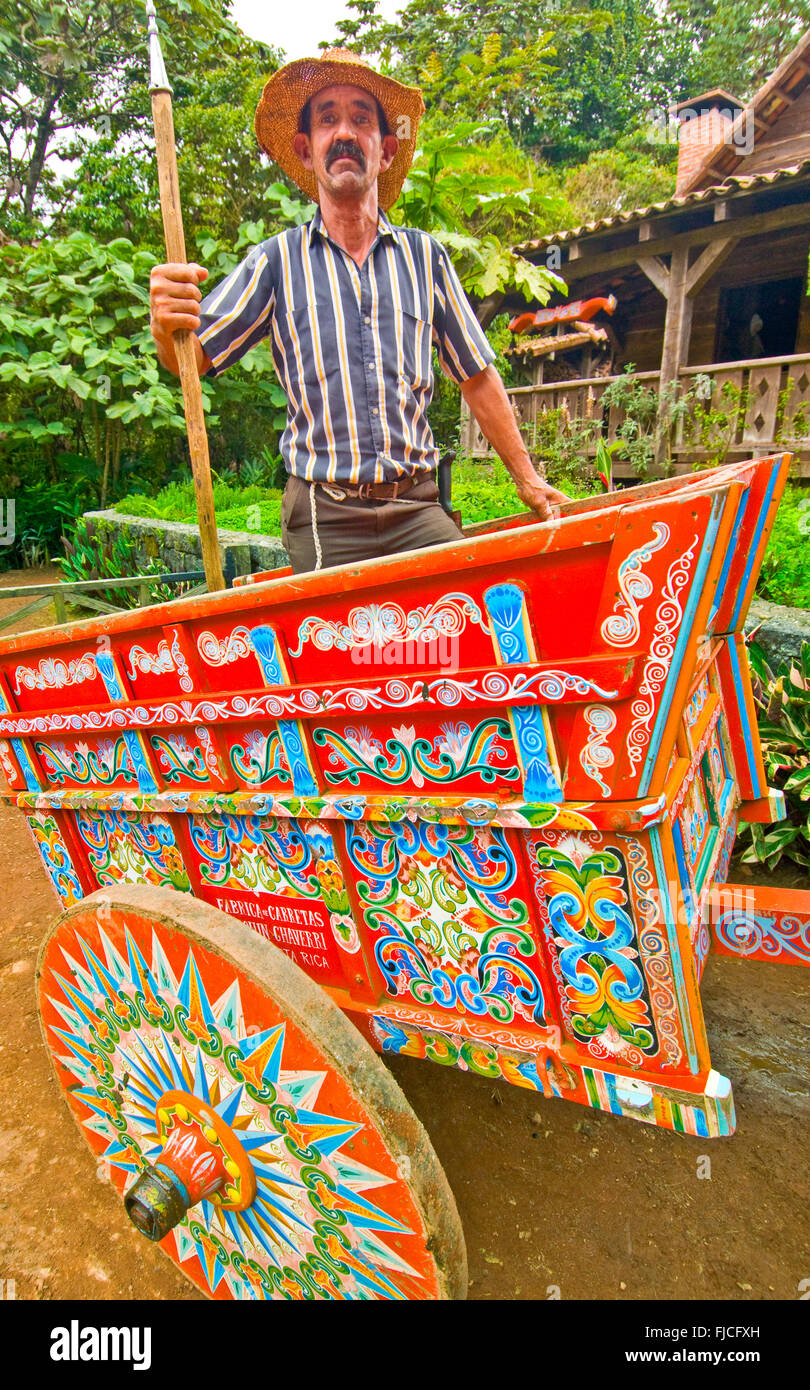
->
xmin=146 ymin=0 xmax=225 ymax=594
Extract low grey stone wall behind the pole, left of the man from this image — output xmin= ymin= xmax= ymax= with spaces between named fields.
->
xmin=83 ymin=510 xmax=289 ymax=578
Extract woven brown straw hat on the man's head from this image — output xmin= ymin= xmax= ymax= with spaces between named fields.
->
xmin=254 ymin=49 xmax=425 ymax=207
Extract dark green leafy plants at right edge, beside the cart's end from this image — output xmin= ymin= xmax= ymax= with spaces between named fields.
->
xmin=739 ymin=642 xmax=810 ymax=869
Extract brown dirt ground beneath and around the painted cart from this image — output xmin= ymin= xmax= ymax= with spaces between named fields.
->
xmin=0 ymin=574 xmax=810 ymax=1301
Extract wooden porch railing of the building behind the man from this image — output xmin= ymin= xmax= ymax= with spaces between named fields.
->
xmin=461 ymin=353 xmax=810 ymax=477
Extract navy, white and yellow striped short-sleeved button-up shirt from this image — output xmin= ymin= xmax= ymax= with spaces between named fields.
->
xmin=199 ymin=209 xmax=495 ymax=482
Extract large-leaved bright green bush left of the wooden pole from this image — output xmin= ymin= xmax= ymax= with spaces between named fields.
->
xmin=0 ymin=232 xmax=185 ymax=559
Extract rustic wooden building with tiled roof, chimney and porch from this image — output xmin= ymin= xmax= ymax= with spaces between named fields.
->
xmin=461 ymin=29 xmax=810 ymax=475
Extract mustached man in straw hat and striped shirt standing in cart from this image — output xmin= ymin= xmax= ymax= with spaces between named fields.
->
xmin=151 ymin=49 xmax=565 ymax=573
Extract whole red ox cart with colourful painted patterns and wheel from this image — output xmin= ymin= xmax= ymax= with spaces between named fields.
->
xmin=0 ymin=456 xmax=809 ymax=1298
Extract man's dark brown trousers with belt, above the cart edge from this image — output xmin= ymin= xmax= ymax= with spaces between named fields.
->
xmin=281 ymin=477 xmax=461 ymax=574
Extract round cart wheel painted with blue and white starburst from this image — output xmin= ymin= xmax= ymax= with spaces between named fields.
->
xmin=38 ymin=887 xmax=467 ymax=1300
